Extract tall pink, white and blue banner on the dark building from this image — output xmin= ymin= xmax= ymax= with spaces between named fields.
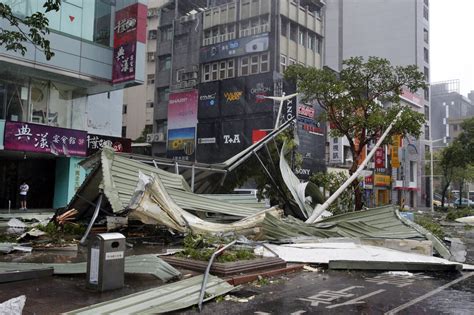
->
xmin=167 ymin=90 xmax=198 ymax=161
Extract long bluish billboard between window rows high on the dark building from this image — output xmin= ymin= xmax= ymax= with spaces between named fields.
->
xmin=199 ymin=33 xmax=269 ymax=63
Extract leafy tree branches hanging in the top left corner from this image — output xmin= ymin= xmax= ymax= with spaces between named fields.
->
xmin=0 ymin=0 xmax=61 ymax=60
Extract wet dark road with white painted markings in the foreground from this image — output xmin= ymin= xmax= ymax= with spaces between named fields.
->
xmin=178 ymin=270 xmax=474 ymax=315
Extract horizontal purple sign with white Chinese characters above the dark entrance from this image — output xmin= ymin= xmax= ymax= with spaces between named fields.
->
xmin=5 ymin=121 xmax=87 ymax=156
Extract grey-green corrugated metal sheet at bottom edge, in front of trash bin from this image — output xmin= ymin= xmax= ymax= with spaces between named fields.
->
xmin=65 ymin=275 xmax=234 ymax=315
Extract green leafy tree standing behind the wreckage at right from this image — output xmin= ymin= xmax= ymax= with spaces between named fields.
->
xmin=285 ymin=57 xmax=426 ymax=210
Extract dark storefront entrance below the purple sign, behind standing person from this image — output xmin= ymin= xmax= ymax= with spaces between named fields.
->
xmin=0 ymin=152 xmax=56 ymax=209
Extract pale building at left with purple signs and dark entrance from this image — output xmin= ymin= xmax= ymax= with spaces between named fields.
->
xmin=0 ymin=0 xmax=146 ymax=208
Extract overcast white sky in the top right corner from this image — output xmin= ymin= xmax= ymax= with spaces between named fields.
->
xmin=430 ymin=0 xmax=474 ymax=96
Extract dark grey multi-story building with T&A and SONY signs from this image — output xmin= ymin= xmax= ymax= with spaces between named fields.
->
xmin=153 ymin=0 xmax=325 ymax=175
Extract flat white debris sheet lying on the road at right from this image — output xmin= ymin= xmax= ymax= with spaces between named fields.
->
xmin=263 ymin=242 xmax=459 ymax=266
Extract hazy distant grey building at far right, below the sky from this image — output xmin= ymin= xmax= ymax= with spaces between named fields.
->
xmin=431 ymin=80 xmax=474 ymax=147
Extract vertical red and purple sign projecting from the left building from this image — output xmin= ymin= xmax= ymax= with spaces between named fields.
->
xmin=112 ymin=3 xmax=147 ymax=84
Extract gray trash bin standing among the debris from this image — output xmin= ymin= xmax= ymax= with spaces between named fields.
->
xmin=87 ymin=233 xmax=125 ymax=291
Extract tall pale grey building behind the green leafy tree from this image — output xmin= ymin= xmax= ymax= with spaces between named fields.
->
xmin=325 ymin=0 xmax=430 ymax=207
